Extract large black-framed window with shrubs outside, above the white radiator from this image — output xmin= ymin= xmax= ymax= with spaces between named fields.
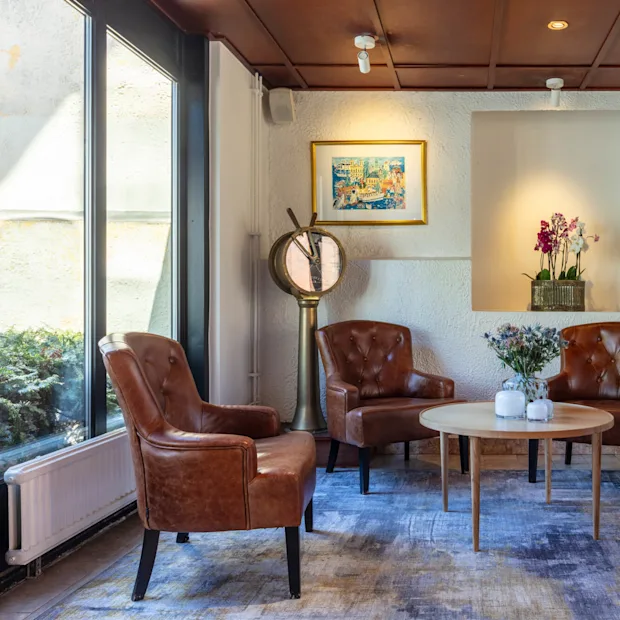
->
xmin=0 ymin=0 xmax=197 ymax=472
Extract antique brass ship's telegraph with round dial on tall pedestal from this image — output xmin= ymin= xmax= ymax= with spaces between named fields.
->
xmin=269 ymin=209 xmax=346 ymax=431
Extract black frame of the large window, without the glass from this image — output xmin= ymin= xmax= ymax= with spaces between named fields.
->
xmin=0 ymin=0 xmax=209 ymax=580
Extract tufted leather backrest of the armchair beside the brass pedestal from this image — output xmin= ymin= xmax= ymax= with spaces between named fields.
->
xmin=317 ymin=321 xmax=413 ymax=399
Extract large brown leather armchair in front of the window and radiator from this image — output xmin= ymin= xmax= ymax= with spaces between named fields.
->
xmin=99 ymin=333 xmax=316 ymax=601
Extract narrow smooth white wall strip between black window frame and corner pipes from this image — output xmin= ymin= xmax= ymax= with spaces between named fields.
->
xmin=209 ymin=43 xmax=264 ymax=404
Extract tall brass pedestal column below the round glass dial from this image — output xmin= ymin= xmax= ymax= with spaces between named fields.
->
xmin=291 ymin=297 xmax=325 ymax=432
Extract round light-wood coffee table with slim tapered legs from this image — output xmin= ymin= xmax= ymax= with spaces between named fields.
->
xmin=420 ymin=402 xmax=614 ymax=551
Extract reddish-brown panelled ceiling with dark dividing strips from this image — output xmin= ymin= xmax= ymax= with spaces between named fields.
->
xmin=151 ymin=0 xmax=620 ymax=90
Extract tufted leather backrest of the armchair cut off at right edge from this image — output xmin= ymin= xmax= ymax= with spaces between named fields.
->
xmin=561 ymin=323 xmax=620 ymax=400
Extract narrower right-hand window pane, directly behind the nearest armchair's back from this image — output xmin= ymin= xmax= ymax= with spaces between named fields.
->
xmin=107 ymin=34 xmax=174 ymax=430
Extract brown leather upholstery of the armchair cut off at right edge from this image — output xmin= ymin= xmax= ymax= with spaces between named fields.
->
xmin=548 ymin=323 xmax=620 ymax=446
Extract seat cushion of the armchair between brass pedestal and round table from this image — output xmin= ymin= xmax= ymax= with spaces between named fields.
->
xmin=346 ymin=398 xmax=461 ymax=448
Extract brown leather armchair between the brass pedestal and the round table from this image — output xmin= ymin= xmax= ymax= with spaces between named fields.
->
xmin=316 ymin=321 xmax=467 ymax=494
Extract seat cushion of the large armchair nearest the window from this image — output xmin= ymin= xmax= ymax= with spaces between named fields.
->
xmin=248 ymin=431 xmax=316 ymax=529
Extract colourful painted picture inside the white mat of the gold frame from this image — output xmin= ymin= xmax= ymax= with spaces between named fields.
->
xmin=332 ymin=156 xmax=407 ymax=210
